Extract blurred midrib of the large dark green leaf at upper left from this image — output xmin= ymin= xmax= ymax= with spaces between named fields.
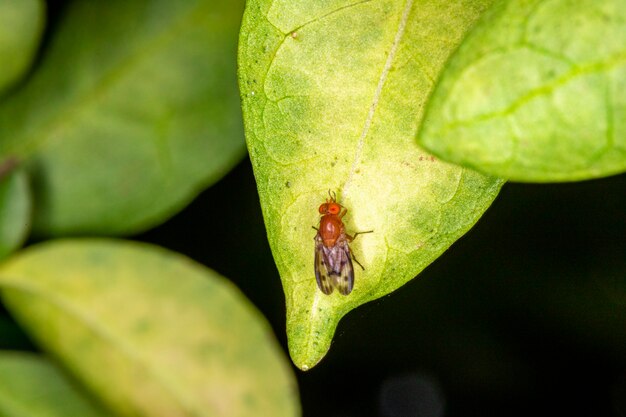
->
xmin=2 ymin=4 xmax=212 ymax=159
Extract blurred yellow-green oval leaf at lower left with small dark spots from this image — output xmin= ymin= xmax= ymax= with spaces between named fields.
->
xmin=0 ymin=239 xmax=299 ymax=417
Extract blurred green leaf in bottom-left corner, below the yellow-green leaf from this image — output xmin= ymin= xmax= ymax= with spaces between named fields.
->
xmin=0 ymin=351 xmax=110 ymax=417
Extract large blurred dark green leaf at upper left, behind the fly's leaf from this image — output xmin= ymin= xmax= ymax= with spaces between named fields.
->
xmin=0 ymin=0 xmax=245 ymax=235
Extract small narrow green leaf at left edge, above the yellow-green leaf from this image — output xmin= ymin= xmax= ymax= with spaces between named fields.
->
xmin=0 ymin=160 xmax=31 ymax=259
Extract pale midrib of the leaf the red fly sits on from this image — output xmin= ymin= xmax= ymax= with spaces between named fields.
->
xmin=342 ymin=0 xmax=413 ymax=197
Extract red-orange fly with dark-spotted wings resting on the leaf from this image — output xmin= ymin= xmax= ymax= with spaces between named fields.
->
xmin=313 ymin=190 xmax=372 ymax=295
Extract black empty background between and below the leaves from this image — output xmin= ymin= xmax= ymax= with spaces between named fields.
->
xmin=0 ymin=159 xmax=626 ymax=417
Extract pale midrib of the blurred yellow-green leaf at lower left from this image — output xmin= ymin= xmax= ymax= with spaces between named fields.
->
xmin=0 ymin=278 xmax=202 ymax=417
